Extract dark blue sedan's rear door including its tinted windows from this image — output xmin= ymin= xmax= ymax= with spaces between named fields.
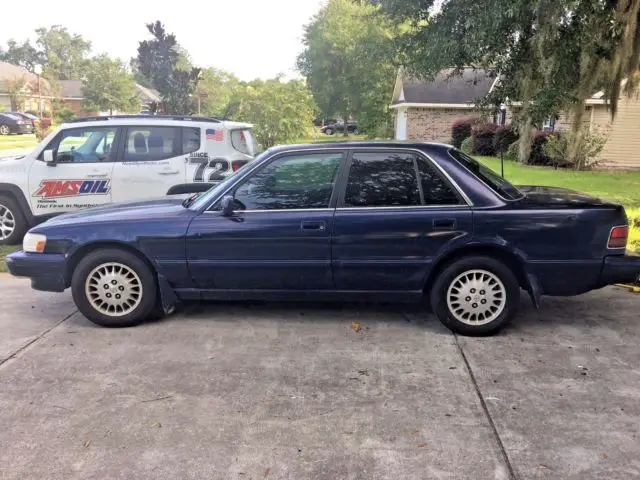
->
xmin=332 ymin=149 xmax=473 ymax=292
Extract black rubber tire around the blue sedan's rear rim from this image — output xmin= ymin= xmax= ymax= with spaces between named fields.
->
xmin=430 ymin=256 xmax=520 ymax=337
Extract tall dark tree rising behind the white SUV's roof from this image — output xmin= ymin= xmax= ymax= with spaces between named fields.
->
xmin=137 ymin=21 xmax=200 ymax=114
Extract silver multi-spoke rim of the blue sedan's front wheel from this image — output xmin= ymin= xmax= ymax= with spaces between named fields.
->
xmin=84 ymin=262 xmax=143 ymax=317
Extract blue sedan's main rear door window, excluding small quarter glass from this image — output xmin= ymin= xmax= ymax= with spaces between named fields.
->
xmin=344 ymin=152 xmax=421 ymax=207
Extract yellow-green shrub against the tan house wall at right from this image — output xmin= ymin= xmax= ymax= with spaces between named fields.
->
xmin=542 ymin=130 xmax=607 ymax=170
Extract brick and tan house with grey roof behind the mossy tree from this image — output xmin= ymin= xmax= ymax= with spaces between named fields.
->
xmin=391 ymin=68 xmax=640 ymax=169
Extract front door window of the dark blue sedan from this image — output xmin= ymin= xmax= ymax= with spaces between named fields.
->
xmin=235 ymin=153 xmax=343 ymax=210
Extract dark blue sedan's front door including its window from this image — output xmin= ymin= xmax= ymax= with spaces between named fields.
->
xmin=187 ymin=150 xmax=345 ymax=291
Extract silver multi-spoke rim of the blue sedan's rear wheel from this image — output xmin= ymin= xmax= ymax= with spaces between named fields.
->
xmin=447 ymin=270 xmax=507 ymax=326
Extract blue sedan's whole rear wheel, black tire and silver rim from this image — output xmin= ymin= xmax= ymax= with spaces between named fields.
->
xmin=431 ymin=256 xmax=520 ymax=336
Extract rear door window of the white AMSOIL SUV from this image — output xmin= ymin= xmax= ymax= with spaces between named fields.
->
xmin=124 ymin=127 xmax=180 ymax=162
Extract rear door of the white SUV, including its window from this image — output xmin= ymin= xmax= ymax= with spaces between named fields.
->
xmin=113 ymin=125 xmax=192 ymax=202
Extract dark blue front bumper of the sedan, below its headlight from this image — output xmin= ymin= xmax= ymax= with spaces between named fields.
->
xmin=6 ymin=251 xmax=67 ymax=292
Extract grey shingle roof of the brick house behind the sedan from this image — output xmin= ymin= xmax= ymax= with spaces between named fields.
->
xmin=392 ymin=68 xmax=497 ymax=107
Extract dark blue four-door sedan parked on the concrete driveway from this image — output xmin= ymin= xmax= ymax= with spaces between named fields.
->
xmin=7 ymin=142 xmax=640 ymax=335
